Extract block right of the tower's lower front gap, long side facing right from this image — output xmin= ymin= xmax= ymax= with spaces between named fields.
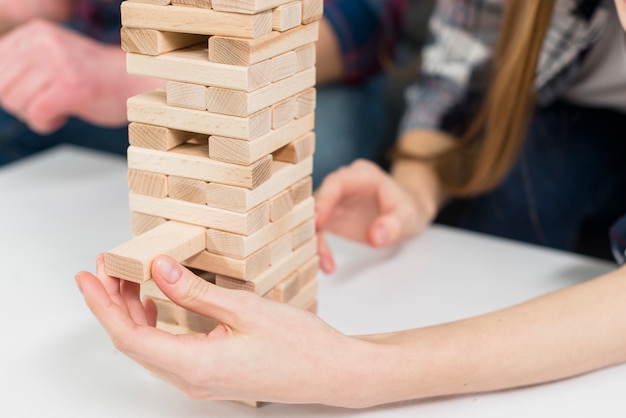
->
xmin=209 ymin=113 xmax=315 ymax=165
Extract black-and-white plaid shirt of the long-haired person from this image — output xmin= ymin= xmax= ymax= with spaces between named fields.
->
xmin=401 ymin=0 xmax=614 ymax=131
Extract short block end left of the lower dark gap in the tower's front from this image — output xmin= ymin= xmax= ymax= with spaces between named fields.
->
xmin=128 ymin=123 xmax=201 ymax=151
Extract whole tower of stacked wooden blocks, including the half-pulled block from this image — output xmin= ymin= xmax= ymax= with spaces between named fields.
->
xmin=105 ymin=0 xmax=323 ymax=352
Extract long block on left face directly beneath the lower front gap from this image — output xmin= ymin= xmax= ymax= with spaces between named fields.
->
xmin=127 ymin=144 xmax=273 ymax=189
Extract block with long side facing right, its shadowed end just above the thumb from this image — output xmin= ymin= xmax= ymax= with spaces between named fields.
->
xmin=215 ymin=238 xmax=317 ymax=295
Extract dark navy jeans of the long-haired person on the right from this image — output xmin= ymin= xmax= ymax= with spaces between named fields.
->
xmin=441 ymin=102 xmax=626 ymax=258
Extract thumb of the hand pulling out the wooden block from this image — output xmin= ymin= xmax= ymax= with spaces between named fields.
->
xmin=151 ymin=255 xmax=240 ymax=328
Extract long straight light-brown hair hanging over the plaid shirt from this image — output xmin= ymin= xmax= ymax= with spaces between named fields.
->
xmin=435 ymin=0 xmax=555 ymax=197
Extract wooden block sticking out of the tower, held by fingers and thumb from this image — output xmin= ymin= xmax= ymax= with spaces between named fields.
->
xmin=104 ymin=220 xmax=206 ymax=283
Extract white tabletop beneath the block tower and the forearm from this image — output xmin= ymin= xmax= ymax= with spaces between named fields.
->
xmin=0 ymin=147 xmax=626 ymax=418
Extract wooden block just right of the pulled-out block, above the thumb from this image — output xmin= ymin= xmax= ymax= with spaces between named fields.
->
xmin=184 ymin=247 xmax=271 ymax=280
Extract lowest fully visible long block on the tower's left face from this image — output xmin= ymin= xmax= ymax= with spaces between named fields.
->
xmin=128 ymin=193 xmax=269 ymax=235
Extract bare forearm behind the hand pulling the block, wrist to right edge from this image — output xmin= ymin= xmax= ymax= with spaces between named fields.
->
xmin=354 ymin=268 xmax=626 ymax=403
